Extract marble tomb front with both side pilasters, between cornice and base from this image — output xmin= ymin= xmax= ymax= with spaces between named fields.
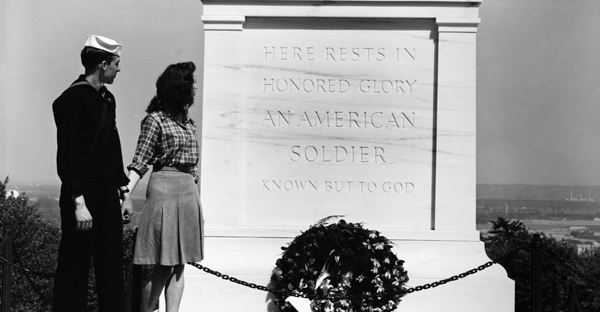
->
xmin=202 ymin=17 xmax=478 ymax=238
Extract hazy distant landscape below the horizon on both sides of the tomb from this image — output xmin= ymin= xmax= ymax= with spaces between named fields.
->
xmin=8 ymin=182 xmax=600 ymax=243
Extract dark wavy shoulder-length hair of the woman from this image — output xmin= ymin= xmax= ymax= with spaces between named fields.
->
xmin=146 ymin=62 xmax=196 ymax=117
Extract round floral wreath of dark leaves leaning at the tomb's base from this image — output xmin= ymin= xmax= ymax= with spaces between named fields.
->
xmin=271 ymin=216 xmax=408 ymax=312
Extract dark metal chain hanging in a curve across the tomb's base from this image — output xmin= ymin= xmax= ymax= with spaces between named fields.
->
xmin=187 ymin=249 xmax=520 ymax=299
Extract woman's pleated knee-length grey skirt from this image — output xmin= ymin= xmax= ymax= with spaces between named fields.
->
xmin=133 ymin=167 xmax=204 ymax=266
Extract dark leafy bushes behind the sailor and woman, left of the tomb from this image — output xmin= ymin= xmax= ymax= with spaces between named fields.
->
xmin=0 ymin=178 xmax=151 ymax=312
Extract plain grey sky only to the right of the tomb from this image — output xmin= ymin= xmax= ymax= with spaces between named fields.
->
xmin=477 ymin=0 xmax=600 ymax=185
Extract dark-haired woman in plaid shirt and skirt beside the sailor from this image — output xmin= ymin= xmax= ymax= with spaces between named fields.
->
xmin=123 ymin=62 xmax=204 ymax=312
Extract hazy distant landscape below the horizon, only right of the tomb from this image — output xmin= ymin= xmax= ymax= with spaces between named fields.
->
xmin=476 ymin=184 xmax=600 ymax=248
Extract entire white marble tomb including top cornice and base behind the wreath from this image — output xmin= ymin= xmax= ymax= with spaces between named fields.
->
xmin=182 ymin=0 xmax=514 ymax=312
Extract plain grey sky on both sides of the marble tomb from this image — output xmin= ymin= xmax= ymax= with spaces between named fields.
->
xmin=0 ymin=0 xmax=600 ymax=185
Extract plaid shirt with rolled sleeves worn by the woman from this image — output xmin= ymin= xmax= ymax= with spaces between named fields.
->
xmin=127 ymin=111 xmax=200 ymax=183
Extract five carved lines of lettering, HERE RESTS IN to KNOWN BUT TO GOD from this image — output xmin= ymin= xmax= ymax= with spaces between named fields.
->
xmin=250 ymin=44 xmax=432 ymax=196
